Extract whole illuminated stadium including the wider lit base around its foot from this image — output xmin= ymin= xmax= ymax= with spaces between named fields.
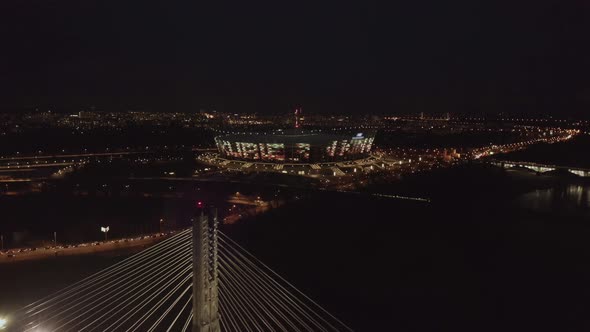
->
xmin=199 ymin=129 xmax=384 ymax=176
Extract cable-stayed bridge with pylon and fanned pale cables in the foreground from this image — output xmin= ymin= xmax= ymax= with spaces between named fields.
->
xmin=8 ymin=212 xmax=351 ymax=332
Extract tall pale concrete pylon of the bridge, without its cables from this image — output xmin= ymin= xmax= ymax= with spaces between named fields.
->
xmin=192 ymin=209 xmax=221 ymax=332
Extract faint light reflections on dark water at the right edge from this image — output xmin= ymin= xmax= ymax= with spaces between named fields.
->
xmin=516 ymin=185 xmax=590 ymax=217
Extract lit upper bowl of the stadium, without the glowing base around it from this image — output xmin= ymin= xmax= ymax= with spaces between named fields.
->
xmin=215 ymin=130 xmax=374 ymax=163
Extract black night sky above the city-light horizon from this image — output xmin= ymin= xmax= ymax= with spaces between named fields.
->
xmin=0 ymin=0 xmax=590 ymax=115
